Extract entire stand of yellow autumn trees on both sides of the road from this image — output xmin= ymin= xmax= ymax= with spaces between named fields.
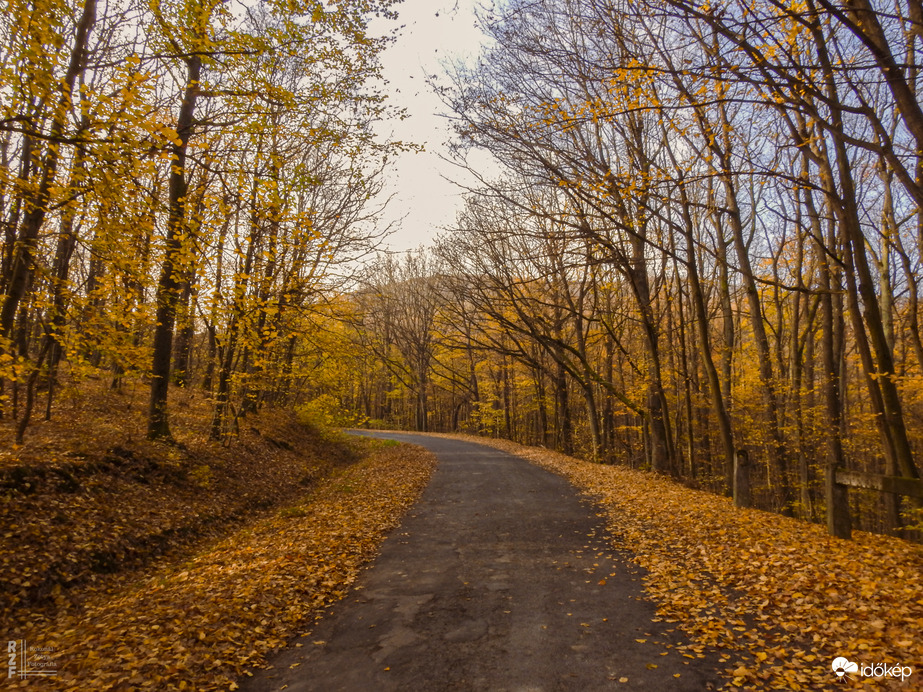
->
xmin=0 ymin=0 xmax=923 ymax=537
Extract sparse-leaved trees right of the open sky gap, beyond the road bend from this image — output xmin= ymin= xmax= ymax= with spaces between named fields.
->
xmin=324 ymin=0 xmax=923 ymax=537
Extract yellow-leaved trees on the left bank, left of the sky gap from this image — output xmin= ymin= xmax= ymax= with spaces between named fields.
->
xmin=0 ymin=0 xmax=404 ymax=444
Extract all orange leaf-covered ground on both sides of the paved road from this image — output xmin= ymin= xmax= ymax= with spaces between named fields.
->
xmin=0 ymin=387 xmax=923 ymax=690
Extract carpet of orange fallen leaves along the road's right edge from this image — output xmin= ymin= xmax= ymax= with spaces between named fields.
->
xmin=456 ymin=436 xmax=923 ymax=690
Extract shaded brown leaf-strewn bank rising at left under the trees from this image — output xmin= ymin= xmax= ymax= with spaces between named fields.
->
xmin=0 ymin=396 xmax=360 ymax=632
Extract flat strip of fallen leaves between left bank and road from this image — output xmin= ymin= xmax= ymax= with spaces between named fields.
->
xmin=4 ymin=446 xmax=434 ymax=690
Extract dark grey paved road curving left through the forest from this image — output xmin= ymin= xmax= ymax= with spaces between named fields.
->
xmin=242 ymin=433 xmax=716 ymax=692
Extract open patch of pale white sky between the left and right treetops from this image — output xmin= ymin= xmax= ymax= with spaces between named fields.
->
xmin=372 ymin=0 xmax=491 ymax=250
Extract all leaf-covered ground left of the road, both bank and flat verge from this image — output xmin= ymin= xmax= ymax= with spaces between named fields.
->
xmin=0 ymin=387 xmax=434 ymax=690
